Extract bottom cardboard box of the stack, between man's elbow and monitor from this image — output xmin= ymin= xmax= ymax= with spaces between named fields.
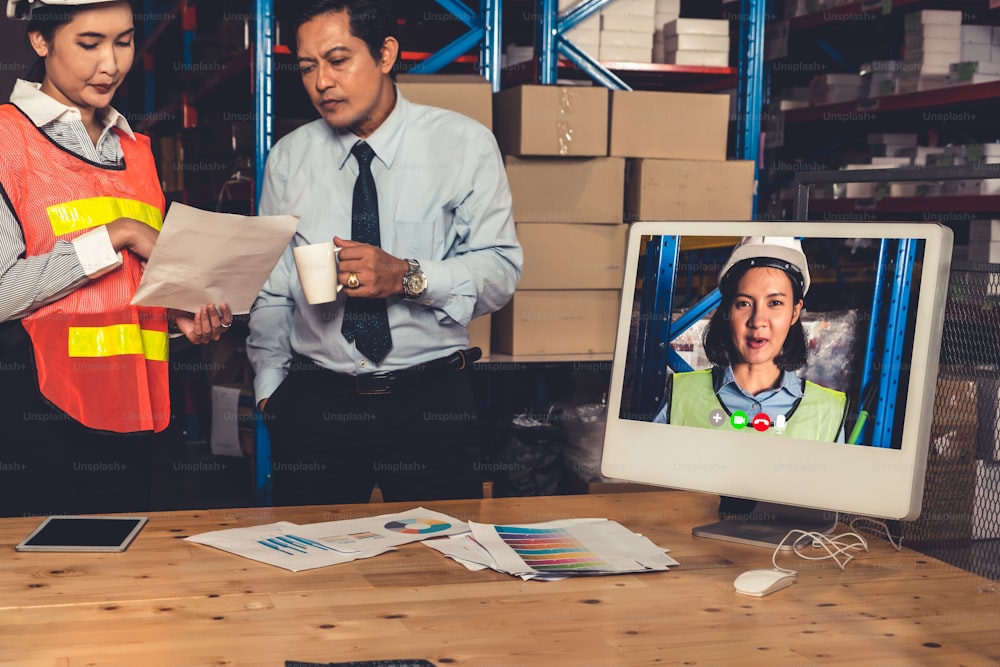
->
xmin=493 ymin=290 xmax=621 ymax=355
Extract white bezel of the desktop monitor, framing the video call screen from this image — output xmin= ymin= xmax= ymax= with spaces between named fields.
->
xmin=601 ymin=221 xmax=952 ymax=520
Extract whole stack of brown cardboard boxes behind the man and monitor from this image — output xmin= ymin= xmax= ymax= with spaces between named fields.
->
xmin=399 ymin=75 xmax=754 ymax=355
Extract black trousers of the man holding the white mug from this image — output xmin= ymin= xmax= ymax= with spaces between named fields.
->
xmin=263 ymin=354 xmax=483 ymax=505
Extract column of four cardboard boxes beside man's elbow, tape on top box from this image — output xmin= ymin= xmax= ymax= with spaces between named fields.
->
xmin=493 ymin=86 xmax=627 ymax=355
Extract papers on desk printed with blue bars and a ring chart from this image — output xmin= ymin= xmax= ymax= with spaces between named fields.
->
xmin=185 ymin=507 xmax=469 ymax=572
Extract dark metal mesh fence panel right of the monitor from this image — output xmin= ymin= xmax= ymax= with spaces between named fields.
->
xmin=900 ymin=262 xmax=1000 ymax=579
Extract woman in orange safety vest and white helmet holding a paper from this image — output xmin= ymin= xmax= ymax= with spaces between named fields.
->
xmin=0 ymin=0 xmax=232 ymax=516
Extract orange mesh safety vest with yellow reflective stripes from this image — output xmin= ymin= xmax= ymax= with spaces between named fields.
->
xmin=0 ymin=104 xmax=170 ymax=433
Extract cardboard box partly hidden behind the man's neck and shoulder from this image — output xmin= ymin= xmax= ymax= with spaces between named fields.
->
xmin=396 ymin=74 xmax=493 ymax=130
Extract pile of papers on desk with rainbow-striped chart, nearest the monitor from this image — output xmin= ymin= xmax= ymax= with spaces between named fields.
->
xmin=425 ymin=519 xmax=678 ymax=581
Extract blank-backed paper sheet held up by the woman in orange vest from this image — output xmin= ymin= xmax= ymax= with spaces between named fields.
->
xmin=132 ymin=202 xmax=298 ymax=315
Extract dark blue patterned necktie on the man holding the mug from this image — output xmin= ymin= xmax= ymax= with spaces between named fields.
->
xmin=340 ymin=141 xmax=392 ymax=364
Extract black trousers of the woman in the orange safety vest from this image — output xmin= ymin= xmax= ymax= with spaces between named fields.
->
xmin=0 ymin=340 xmax=160 ymax=516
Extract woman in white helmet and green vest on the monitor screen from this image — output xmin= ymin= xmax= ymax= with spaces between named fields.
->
xmin=653 ymin=236 xmax=847 ymax=442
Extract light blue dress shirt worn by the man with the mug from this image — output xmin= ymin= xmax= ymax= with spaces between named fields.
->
xmin=247 ymin=89 xmax=524 ymax=402
